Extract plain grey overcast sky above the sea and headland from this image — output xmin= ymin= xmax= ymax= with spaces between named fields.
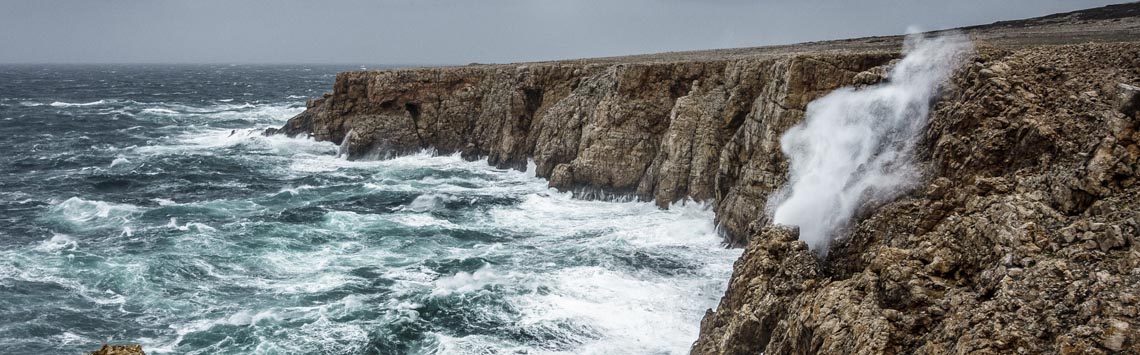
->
xmin=0 ymin=0 xmax=1124 ymax=64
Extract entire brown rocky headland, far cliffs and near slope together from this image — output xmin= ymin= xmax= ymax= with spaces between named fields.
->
xmin=262 ymin=3 xmax=1140 ymax=355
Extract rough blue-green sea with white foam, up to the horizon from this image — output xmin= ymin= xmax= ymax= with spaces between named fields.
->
xmin=0 ymin=66 xmax=739 ymax=354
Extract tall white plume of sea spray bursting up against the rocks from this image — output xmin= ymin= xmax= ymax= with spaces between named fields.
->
xmin=768 ymin=34 xmax=972 ymax=253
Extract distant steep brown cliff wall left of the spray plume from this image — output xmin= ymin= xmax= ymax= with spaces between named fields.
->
xmin=282 ymin=51 xmax=896 ymax=245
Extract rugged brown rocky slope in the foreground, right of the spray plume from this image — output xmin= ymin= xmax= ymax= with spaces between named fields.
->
xmin=693 ymin=43 xmax=1140 ymax=354
